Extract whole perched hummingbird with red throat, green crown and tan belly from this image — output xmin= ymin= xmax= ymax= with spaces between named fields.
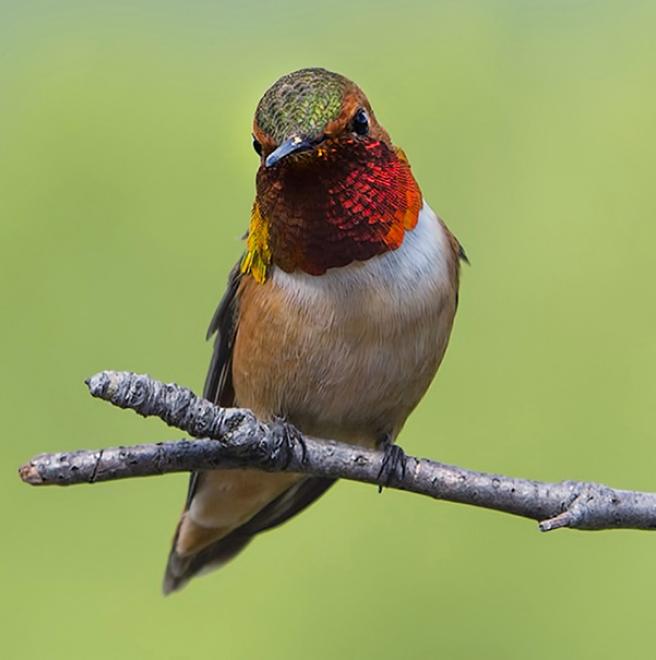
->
xmin=164 ymin=68 xmax=466 ymax=593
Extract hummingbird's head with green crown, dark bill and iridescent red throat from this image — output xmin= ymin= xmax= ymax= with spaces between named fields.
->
xmin=242 ymin=68 xmax=422 ymax=281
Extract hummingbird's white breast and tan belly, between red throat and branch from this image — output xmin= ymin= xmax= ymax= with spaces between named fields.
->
xmin=233 ymin=207 xmax=456 ymax=444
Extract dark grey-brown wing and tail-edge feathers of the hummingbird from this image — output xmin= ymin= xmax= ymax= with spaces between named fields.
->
xmin=164 ymin=263 xmax=335 ymax=593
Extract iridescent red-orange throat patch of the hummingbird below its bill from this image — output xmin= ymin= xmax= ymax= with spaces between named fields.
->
xmin=242 ymin=138 xmax=422 ymax=282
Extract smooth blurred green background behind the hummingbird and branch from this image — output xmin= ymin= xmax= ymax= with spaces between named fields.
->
xmin=0 ymin=0 xmax=656 ymax=660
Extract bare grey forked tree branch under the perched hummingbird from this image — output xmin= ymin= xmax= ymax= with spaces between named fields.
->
xmin=19 ymin=371 xmax=656 ymax=531
